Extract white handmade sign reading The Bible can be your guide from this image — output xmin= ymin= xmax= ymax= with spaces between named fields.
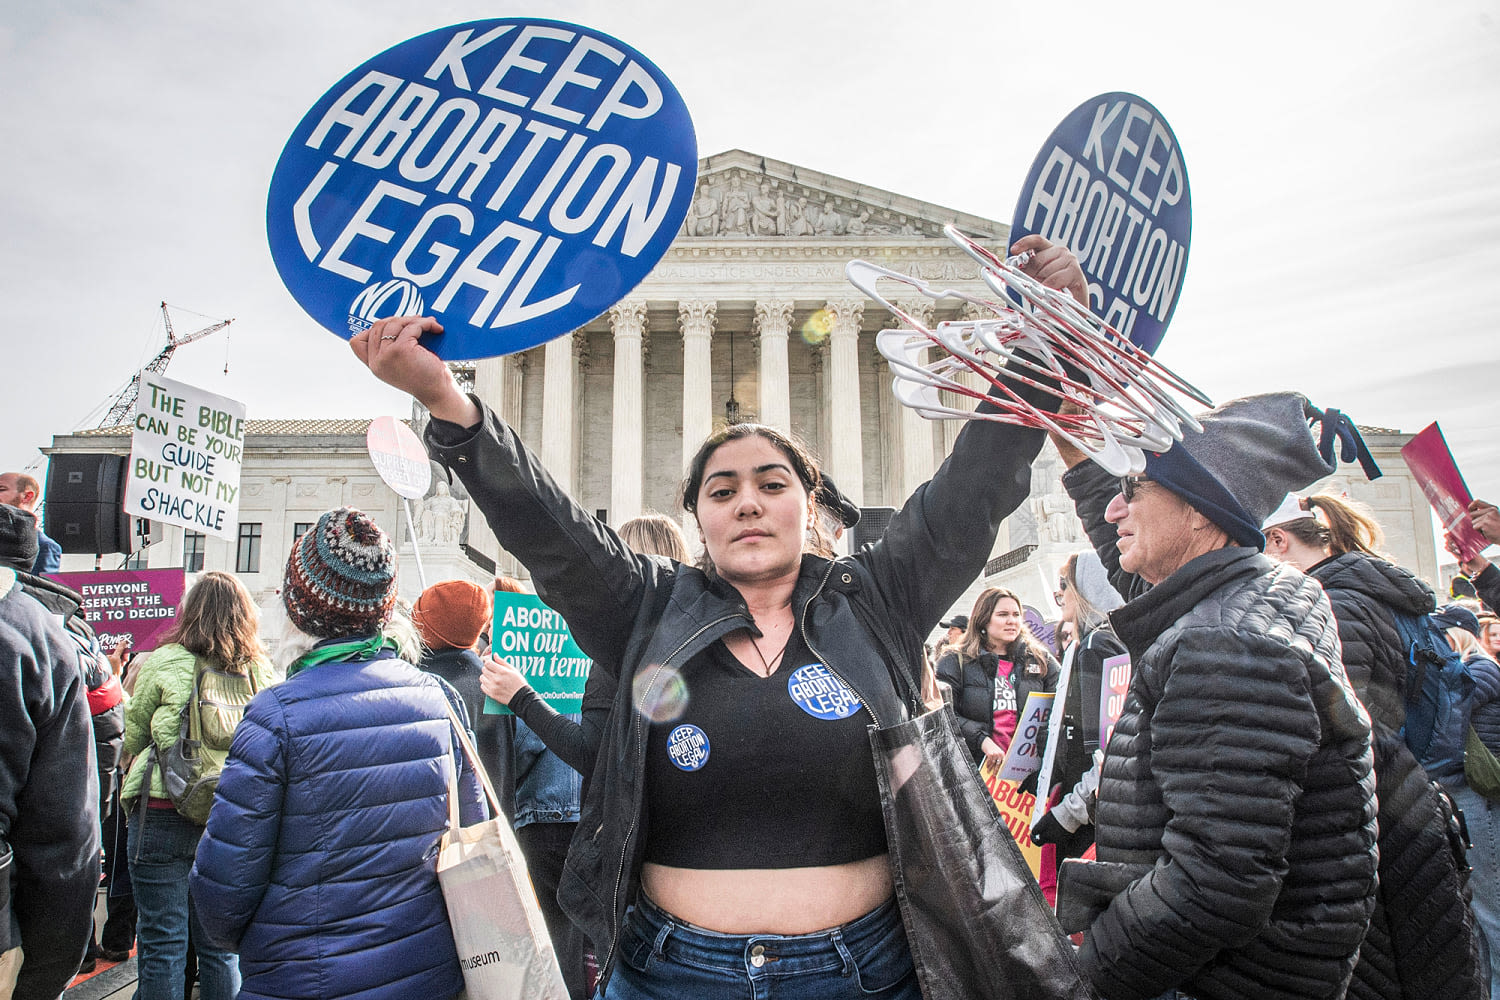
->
xmin=125 ymin=372 xmax=245 ymax=540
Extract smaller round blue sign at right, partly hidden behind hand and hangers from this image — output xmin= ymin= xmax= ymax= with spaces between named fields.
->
xmin=1011 ymin=93 xmax=1193 ymax=351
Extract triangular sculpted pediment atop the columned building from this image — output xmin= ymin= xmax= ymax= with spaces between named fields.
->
xmin=683 ymin=150 xmax=1008 ymax=241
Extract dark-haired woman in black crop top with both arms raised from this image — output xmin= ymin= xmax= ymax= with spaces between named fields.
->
xmin=351 ymin=238 xmax=1082 ymax=1000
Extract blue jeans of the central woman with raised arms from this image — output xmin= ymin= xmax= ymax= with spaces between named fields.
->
xmin=597 ymin=894 xmax=921 ymax=1000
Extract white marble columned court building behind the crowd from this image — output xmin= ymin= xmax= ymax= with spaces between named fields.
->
xmin=48 ymin=150 xmax=1439 ymax=626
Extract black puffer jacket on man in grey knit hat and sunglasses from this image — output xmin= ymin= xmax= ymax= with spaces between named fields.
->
xmin=1064 ymin=463 xmax=1376 ymax=1000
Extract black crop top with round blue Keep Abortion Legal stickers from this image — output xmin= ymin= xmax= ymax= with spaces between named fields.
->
xmin=645 ymin=630 xmax=887 ymax=868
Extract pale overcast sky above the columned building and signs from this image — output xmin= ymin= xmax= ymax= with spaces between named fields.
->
xmin=0 ymin=0 xmax=1500 ymax=515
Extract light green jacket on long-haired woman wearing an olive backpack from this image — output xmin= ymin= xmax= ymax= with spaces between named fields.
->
xmin=120 ymin=643 xmax=276 ymax=813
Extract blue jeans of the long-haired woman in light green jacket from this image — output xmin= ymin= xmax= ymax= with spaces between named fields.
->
xmin=128 ymin=807 xmax=240 ymax=1000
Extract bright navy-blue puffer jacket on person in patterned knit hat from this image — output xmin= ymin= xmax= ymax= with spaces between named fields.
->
xmin=192 ymin=657 xmax=486 ymax=1000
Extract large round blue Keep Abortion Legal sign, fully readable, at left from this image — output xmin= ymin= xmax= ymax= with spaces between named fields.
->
xmin=266 ymin=18 xmax=698 ymax=360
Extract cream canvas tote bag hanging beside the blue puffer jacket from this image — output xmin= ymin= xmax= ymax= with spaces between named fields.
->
xmin=438 ymin=699 xmax=569 ymax=1000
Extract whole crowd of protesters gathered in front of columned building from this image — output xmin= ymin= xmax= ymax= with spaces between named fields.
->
xmin=0 ymin=237 xmax=1500 ymax=1000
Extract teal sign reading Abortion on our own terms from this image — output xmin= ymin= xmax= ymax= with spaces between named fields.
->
xmin=485 ymin=591 xmax=593 ymax=715
